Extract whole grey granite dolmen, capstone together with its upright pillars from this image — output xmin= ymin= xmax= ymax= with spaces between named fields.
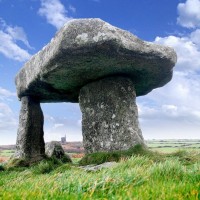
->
xmin=14 ymin=19 xmax=176 ymax=163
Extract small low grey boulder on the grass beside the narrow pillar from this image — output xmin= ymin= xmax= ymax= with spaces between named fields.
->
xmin=45 ymin=141 xmax=72 ymax=162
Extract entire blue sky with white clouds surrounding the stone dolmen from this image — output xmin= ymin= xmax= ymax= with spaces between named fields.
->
xmin=0 ymin=0 xmax=200 ymax=145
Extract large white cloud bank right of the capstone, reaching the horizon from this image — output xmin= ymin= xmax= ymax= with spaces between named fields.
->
xmin=138 ymin=27 xmax=200 ymax=138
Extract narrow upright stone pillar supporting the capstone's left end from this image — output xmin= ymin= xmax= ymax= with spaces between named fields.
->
xmin=14 ymin=96 xmax=45 ymax=163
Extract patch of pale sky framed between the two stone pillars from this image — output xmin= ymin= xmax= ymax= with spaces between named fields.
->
xmin=41 ymin=103 xmax=82 ymax=142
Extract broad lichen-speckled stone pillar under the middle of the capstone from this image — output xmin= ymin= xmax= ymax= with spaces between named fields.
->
xmin=79 ymin=77 xmax=144 ymax=153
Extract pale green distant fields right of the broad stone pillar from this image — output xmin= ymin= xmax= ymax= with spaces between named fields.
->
xmin=146 ymin=139 xmax=200 ymax=153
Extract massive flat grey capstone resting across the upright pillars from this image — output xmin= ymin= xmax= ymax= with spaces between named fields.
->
xmin=16 ymin=19 xmax=176 ymax=102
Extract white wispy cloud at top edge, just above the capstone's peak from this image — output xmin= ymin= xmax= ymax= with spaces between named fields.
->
xmin=38 ymin=0 xmax=75 ymax=29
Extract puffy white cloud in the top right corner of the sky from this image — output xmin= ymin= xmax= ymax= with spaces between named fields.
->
xmin=177 ymin=0 xmax=200 ymax=28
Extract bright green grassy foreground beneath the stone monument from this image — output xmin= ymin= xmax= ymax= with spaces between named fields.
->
xmin=0 ymin=148 xmax=200 ymax=200
